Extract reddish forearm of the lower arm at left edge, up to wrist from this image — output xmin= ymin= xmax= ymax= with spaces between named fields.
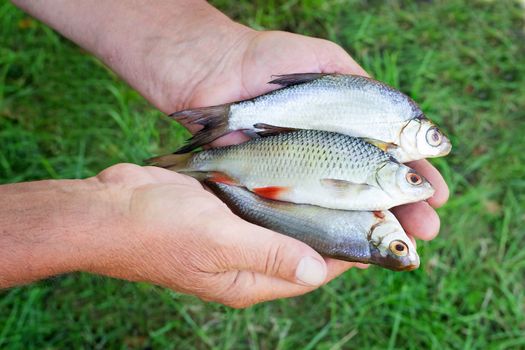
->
xmin=0 ymin=179 xmax=118 ymax=288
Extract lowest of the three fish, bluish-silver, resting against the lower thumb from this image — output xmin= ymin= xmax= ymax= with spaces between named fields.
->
xmin=206 ymin=182 xmax=419 ymax=271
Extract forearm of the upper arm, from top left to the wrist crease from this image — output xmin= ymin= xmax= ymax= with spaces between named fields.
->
xmin=14 ymin=0 xmax=249 ymax=112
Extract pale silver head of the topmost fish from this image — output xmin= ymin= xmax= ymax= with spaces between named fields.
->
xmin=398 ymin=117 xmax=452 ymax=162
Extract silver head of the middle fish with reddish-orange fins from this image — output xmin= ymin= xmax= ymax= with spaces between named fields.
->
xmin=376 ymin=161 xmax=434 ymax=203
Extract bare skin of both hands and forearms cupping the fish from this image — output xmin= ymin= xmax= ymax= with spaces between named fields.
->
xmin=0 ymin=0 xmax=448 ymax=307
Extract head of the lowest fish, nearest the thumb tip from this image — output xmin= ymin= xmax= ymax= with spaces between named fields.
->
xmin=369 ymin=211 xmax=419 ymax=271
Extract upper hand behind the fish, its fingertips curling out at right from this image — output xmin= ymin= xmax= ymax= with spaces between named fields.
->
xmin=145 ymin=32 xmax=448 ymax=274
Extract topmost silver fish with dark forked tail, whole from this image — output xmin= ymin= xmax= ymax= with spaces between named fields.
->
xmin=170 ymin=73 xmax=452 ymax=163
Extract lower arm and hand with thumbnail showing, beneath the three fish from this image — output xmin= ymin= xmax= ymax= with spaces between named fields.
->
xmin=0 ymin=164 xmax=356 ymax=307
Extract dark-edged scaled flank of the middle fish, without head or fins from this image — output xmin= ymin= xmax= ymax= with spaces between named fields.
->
xmin=190 ymin=130 xmax=391 ymax=186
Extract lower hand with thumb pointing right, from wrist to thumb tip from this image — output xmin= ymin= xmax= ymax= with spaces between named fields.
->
xmin=84 ymin=164 xmax=356 ymax=307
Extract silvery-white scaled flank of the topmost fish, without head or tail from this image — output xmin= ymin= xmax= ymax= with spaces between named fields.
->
xmin=229 ymin=75 xmax=421 ymax=139
